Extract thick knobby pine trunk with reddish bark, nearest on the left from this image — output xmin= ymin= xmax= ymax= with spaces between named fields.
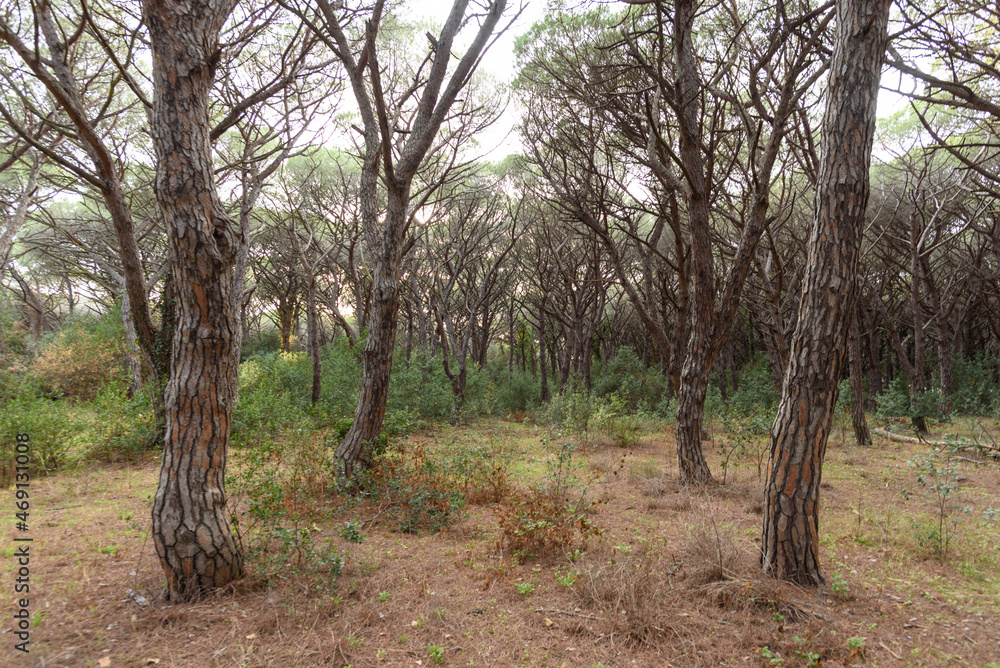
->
xmin=143 ymin=0 xmax=243 ymax=601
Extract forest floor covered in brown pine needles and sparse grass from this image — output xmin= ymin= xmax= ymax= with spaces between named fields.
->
xmin=0 ymin=414 xmax=1000 ymax=668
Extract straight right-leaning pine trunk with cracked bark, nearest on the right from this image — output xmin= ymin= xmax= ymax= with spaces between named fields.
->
xmin=761 ymin=0 xmax=890 ymax=586
